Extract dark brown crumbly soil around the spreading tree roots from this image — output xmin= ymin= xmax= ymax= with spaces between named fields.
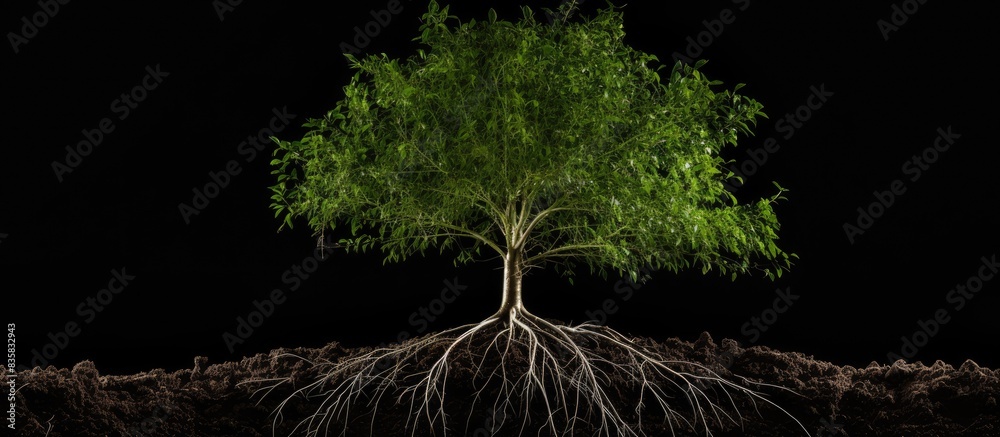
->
xmin=9 ymin=333 xmax=1000 ymax=437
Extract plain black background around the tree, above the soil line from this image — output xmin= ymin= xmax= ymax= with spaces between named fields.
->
xmin=0 ymin=0 xmax=1000 ymax=373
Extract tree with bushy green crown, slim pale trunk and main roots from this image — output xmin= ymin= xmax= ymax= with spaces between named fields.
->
xmin=260 ymin=1 xmax=794 ymax=432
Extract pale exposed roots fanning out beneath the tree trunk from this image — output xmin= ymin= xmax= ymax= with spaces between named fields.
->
xmin=242 ymin=308 xmax=809 ymax=436
